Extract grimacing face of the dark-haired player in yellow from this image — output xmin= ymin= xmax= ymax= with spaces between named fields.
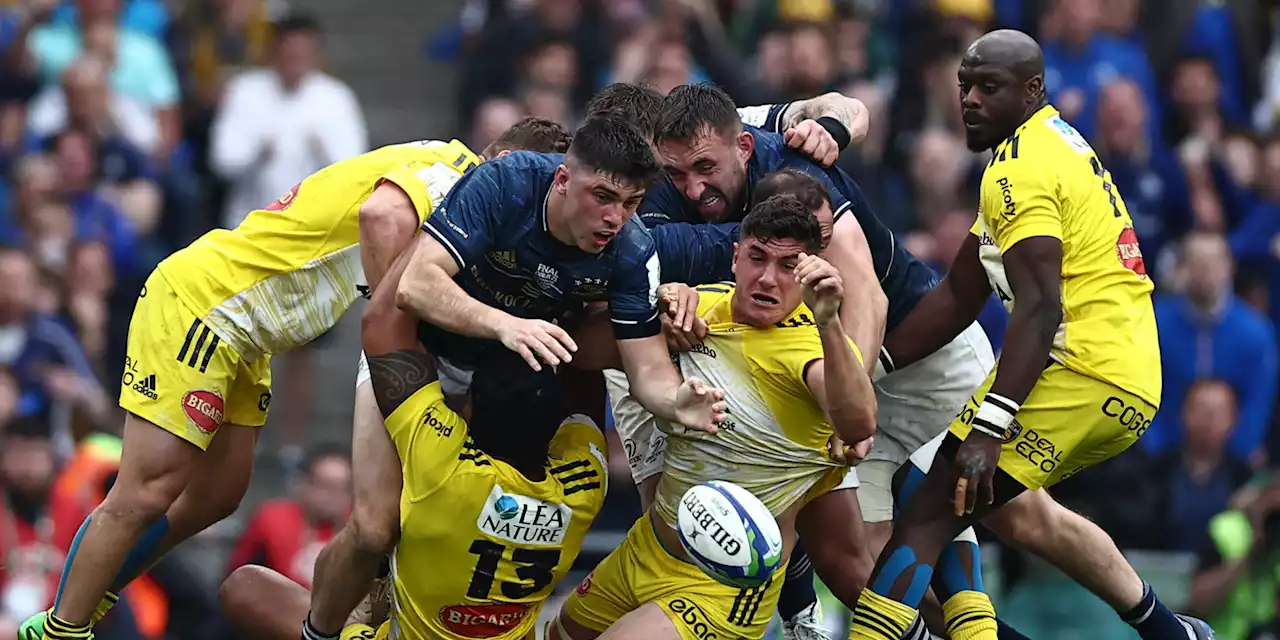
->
xmin=733 ymin=238 xmax=805 ymax=326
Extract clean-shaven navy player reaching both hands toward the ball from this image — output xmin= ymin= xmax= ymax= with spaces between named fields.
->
xmin=397 ymin=118 xmax=724 ymax=433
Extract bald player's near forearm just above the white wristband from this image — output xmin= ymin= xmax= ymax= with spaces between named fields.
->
xmin=988 ymin=297 xmax=1062 ymax=406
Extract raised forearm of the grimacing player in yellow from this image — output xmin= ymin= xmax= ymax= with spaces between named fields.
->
xmin=818 ymin=318 xmax=876 ymax=443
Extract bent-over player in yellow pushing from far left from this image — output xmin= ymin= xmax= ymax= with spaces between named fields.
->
xmin=20 ymin=120 xmax=563 ymax=640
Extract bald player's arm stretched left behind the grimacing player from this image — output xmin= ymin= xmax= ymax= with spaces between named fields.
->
xmin=884 ymin=275 xmax=989 ymax=369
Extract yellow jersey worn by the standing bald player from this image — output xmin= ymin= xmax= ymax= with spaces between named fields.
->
xmin=970 ymin=106 xmax=1161 ymax=406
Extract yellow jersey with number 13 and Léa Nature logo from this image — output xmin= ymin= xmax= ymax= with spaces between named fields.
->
xmin=387 ymin=383 xmax=608 ymax=640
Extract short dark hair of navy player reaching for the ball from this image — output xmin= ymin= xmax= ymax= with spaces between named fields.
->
xmin=568 ymin=115 xmax=662 ymax=187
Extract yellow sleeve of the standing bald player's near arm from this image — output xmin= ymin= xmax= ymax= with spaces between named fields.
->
xmin=982 ymin=156 xmax=1062 ymax=252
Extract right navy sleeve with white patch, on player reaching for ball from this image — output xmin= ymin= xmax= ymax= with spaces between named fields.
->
xmin=609 ymin=219 xmax=662 ymax=340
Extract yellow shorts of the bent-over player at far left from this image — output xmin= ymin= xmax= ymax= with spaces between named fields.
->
xmin=120 ymin=271 xmax=271 ymax=449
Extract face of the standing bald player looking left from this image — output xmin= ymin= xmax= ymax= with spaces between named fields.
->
xmin=956 ymin=57 xmax=1028 ymax=151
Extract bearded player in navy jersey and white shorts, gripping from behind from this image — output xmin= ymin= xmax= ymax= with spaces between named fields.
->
xmin=593 ymin=86 xmax=995 ymax=632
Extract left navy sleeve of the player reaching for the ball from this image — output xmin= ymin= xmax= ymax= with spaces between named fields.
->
xmin=422 ymin=163 xmax=501 ymax=269
